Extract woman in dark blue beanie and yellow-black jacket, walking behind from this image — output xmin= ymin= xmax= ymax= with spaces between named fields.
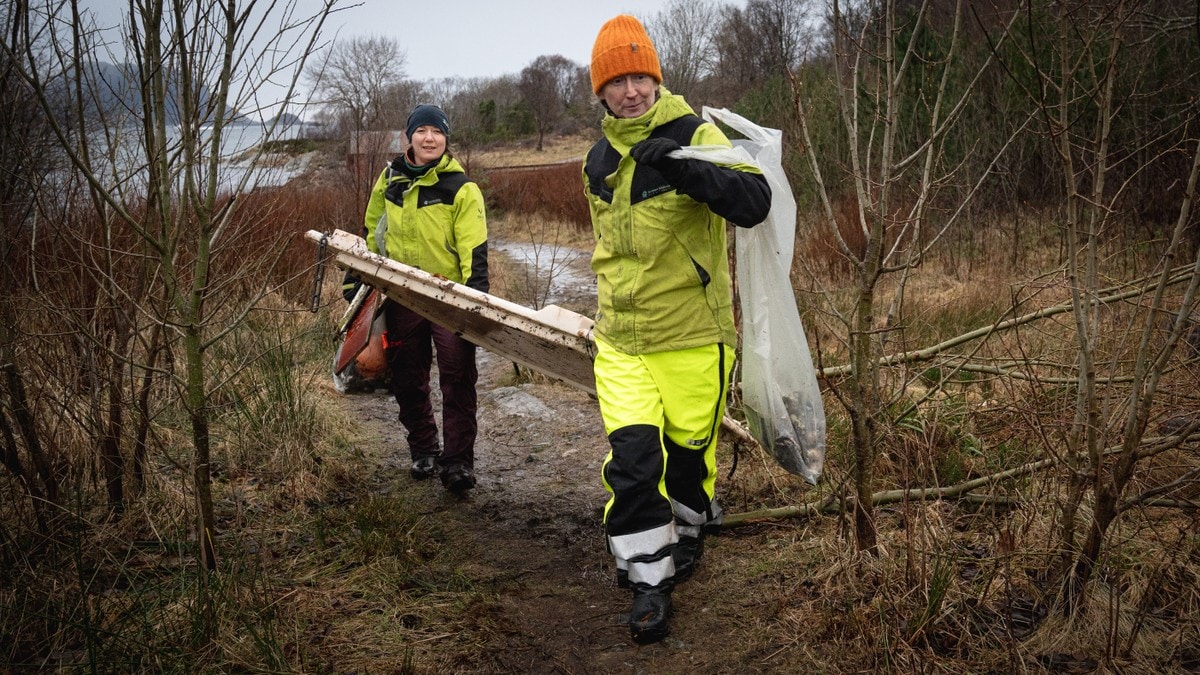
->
xmin=343 ymin=104 xmax=488 ymax=496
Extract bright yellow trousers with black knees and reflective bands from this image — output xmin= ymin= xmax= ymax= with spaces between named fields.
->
xmin=594 ymin=338 xmax=733 ymax=586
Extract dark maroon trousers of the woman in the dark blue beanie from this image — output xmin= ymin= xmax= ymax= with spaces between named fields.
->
xmin=384 ymin=300 xmax=479 ymax=470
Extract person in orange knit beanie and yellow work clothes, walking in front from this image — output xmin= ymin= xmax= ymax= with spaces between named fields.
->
xmin=583 ymin=14 xmax=770 ymax=644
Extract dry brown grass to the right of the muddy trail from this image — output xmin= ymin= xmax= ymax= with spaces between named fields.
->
xmin=725 ymin=205 xmax=1200 ymax=673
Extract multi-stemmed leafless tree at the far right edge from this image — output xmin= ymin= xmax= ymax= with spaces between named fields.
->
xmin=1021 ymin=1 xmax=1200 ymax=611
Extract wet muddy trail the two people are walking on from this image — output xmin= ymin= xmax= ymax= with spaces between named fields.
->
xmin=328 ymin=240 xmax=806 ymax=673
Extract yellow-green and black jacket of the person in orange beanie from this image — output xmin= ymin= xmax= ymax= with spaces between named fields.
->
xmin=583 ymin=88 xmax=770 ymax=354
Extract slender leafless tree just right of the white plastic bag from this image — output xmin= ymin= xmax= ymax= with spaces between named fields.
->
xmin=796 ymin=1 xmax=1022 ymax=552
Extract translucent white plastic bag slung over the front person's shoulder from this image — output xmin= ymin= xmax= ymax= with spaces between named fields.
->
xmin=672 ymin=107 xmax=826 ymax=484
